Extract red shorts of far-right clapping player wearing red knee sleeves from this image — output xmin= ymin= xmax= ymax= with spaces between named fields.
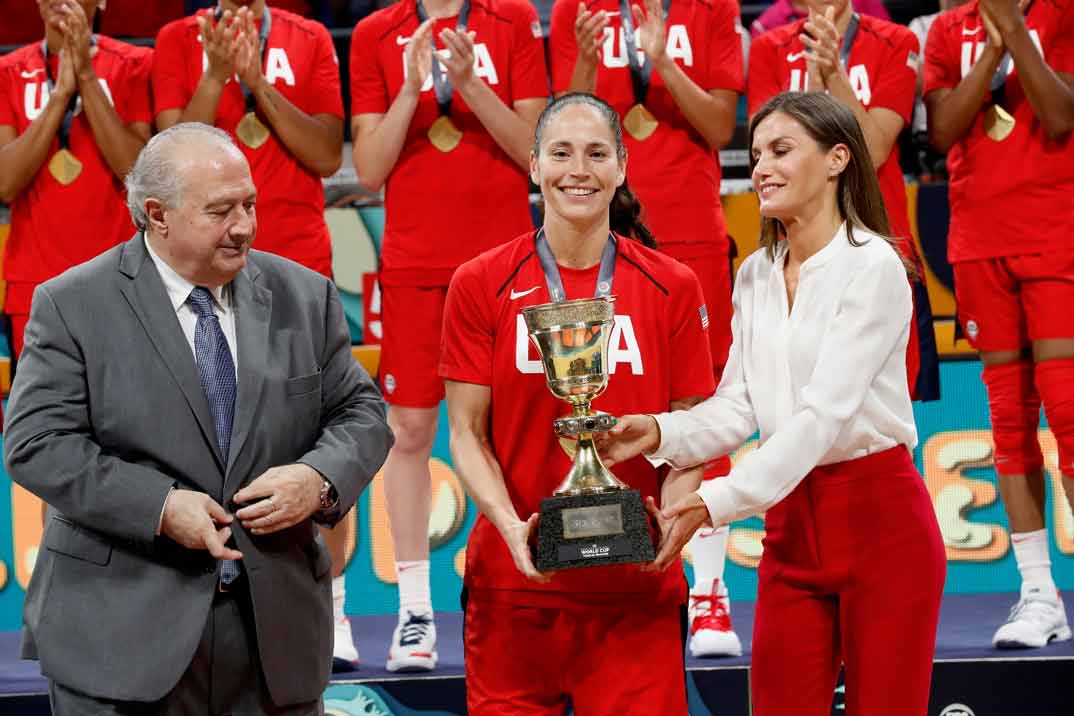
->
xmin=954 ymin=251 xmax=1074 ymax=351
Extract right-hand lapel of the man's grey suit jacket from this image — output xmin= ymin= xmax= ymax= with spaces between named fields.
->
xmin=224 ymin=260 xmax=272 ymax=494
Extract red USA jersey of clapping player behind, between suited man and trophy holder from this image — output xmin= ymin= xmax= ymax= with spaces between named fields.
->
xmin=350 ymin=0 xmax=548 ymax=286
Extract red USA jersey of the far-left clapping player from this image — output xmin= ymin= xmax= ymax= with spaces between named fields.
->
xmin=0 ymin=35 xmax=153 ymax=291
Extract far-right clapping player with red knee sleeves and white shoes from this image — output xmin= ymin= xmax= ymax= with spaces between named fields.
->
xmin=924 ymin=0 xmax=1074 ymax=647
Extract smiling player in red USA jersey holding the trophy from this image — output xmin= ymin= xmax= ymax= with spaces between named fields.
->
xmin=440 ymin=93 xmax=713 ymax=716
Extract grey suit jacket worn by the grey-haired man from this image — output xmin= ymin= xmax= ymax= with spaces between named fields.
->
xmin=4 ymin=234 xmax=392 ymax=705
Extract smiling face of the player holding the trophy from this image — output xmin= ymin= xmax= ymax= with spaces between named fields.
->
xmin=529 ymin=103 xmax=626 ymax=229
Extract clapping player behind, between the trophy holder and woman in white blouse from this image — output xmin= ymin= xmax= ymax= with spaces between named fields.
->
xmin=550 ymin=0 xmax=745 ymax=656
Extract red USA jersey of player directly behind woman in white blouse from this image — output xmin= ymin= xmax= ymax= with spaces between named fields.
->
xmin=746 ymin=15 xmax=918 ymax=246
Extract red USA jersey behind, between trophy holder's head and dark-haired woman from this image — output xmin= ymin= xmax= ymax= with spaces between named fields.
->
xmin=549 ymin=0 xmax=745 ymax=253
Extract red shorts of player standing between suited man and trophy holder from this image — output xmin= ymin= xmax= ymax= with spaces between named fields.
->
xmin=379 ymin=286 xmax=448 ymax=408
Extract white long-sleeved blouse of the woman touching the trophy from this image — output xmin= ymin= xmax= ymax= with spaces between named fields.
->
xmin=651 ymin=224 xmax=917 ymax=525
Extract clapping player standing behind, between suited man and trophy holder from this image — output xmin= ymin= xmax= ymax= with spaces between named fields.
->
xmin=350 ymin=0 xmax=548 ymax=671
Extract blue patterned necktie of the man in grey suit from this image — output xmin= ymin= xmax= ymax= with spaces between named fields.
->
xmin=187 ymin=286 xmax=241 ymax=584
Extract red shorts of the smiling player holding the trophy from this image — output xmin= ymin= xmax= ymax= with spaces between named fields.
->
xmin=463 ymin=596 xmax=686 ymax=716
